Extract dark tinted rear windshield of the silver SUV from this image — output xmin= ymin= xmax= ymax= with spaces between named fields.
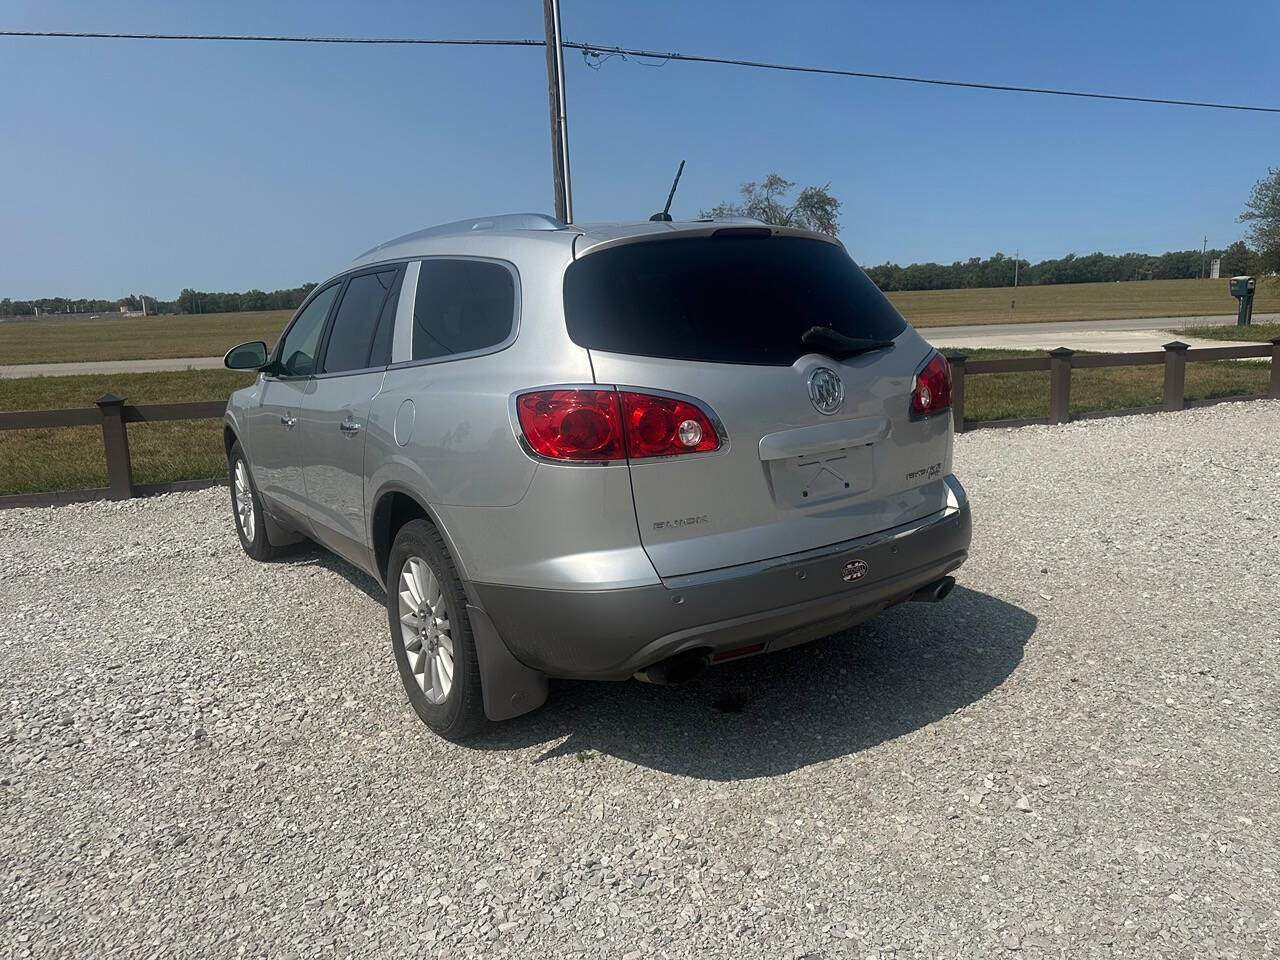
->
xmin=564 ymin=236 xmax=906 ymax=366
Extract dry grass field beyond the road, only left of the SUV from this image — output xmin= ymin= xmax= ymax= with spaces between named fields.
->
xmin=0 ymin=310 xmax=293 ymax=365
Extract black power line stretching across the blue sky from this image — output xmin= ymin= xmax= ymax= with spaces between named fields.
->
xmin=0 ymin=29 xmax=1280 ymax=114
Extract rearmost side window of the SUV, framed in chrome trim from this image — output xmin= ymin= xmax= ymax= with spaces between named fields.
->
xmin=413 ymin=260 xmax=516 ymax=360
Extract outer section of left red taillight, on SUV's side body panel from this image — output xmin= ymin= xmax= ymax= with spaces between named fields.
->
xmin=516 ymin=390 xmax=625 ymax=461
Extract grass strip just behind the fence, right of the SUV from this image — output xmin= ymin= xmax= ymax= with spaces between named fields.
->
xmin=943 ymin=349 xmax=1271 ymax=421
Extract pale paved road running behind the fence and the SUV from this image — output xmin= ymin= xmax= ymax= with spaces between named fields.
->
xmin=0 ymin=314 xmax=1280 ymax=379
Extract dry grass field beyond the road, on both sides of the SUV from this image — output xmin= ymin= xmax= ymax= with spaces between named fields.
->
xmin=0 ymin=280 xmax=1280 ymax=364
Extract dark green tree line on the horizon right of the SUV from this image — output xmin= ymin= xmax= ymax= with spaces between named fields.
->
xmin=865 ymin=241 xmax=1262 ymax=291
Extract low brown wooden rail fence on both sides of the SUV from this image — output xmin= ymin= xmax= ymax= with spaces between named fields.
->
xmin=0 ymin=337 xmax=1280 ymax=508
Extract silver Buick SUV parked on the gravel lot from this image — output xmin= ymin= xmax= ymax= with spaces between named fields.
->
xmin=225 ymin=214 xmax=970 ymax=739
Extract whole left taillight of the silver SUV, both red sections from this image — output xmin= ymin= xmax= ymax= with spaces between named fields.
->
xmin=516 ymin=388 xmax=719 ymax=462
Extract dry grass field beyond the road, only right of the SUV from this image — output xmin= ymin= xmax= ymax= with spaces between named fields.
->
xmin=888 ymin=280 xmax=1280 ymax=326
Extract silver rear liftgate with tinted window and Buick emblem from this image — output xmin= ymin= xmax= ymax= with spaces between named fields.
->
xmin=564 ymin=228 xmax=951 ymax=576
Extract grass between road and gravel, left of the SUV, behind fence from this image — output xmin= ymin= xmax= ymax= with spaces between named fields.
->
xmin=0 ymin=370 xmax=253 ymax=495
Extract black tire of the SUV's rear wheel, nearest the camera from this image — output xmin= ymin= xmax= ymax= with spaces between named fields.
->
xmin=387 ymin=520 xmax=488 ymax=741
